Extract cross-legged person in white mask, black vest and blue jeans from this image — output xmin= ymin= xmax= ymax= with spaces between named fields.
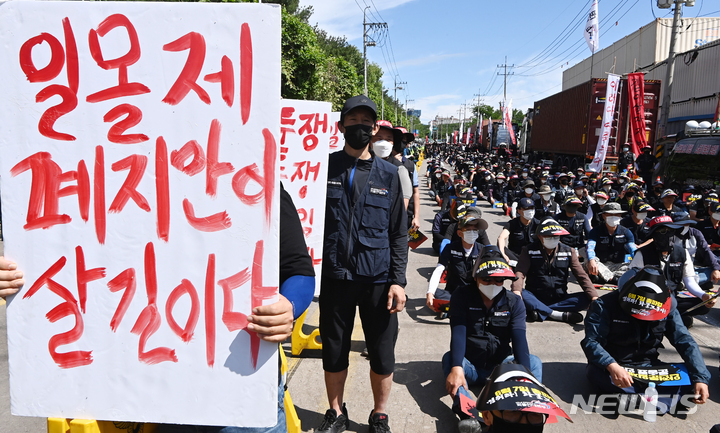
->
xmin=511 ymin=218 xmax=598 ymax=323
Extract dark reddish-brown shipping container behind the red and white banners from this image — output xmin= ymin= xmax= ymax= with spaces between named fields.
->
xmin=529 ymin=78 xmax=661 ymax=170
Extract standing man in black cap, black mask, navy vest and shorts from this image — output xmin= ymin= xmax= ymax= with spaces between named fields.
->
xmin=315 ymin=95 xmax=408 ymax=433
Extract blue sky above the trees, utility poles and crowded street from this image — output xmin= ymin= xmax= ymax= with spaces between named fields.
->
xmin=300 ymin=0 xmax=720 ymax=123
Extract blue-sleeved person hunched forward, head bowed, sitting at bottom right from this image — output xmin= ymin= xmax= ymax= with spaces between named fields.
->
xmin=580 ymin=266 xmax=711 ymax=413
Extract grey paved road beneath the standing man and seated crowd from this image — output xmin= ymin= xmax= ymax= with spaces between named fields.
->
xmin=0 ymin=160 xmax=720 ymax=433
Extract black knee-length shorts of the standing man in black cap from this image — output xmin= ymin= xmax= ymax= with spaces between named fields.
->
xmin=320 ymin=277 xmax=398 ymax=375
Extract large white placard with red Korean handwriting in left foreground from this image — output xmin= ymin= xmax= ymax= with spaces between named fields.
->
xmin=0 ymin=1 xmax=281 ymax=426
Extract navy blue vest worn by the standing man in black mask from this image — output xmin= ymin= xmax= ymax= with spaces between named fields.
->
xmin=323 ymin=150 xmax=399 ymax=283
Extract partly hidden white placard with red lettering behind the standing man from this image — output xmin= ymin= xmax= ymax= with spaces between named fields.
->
xmin=280 ymin=99 xmax=337 ymax=295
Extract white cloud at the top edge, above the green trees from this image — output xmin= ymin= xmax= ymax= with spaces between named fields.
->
xmin=300 ymin=0 xmax=415 ymax=41
